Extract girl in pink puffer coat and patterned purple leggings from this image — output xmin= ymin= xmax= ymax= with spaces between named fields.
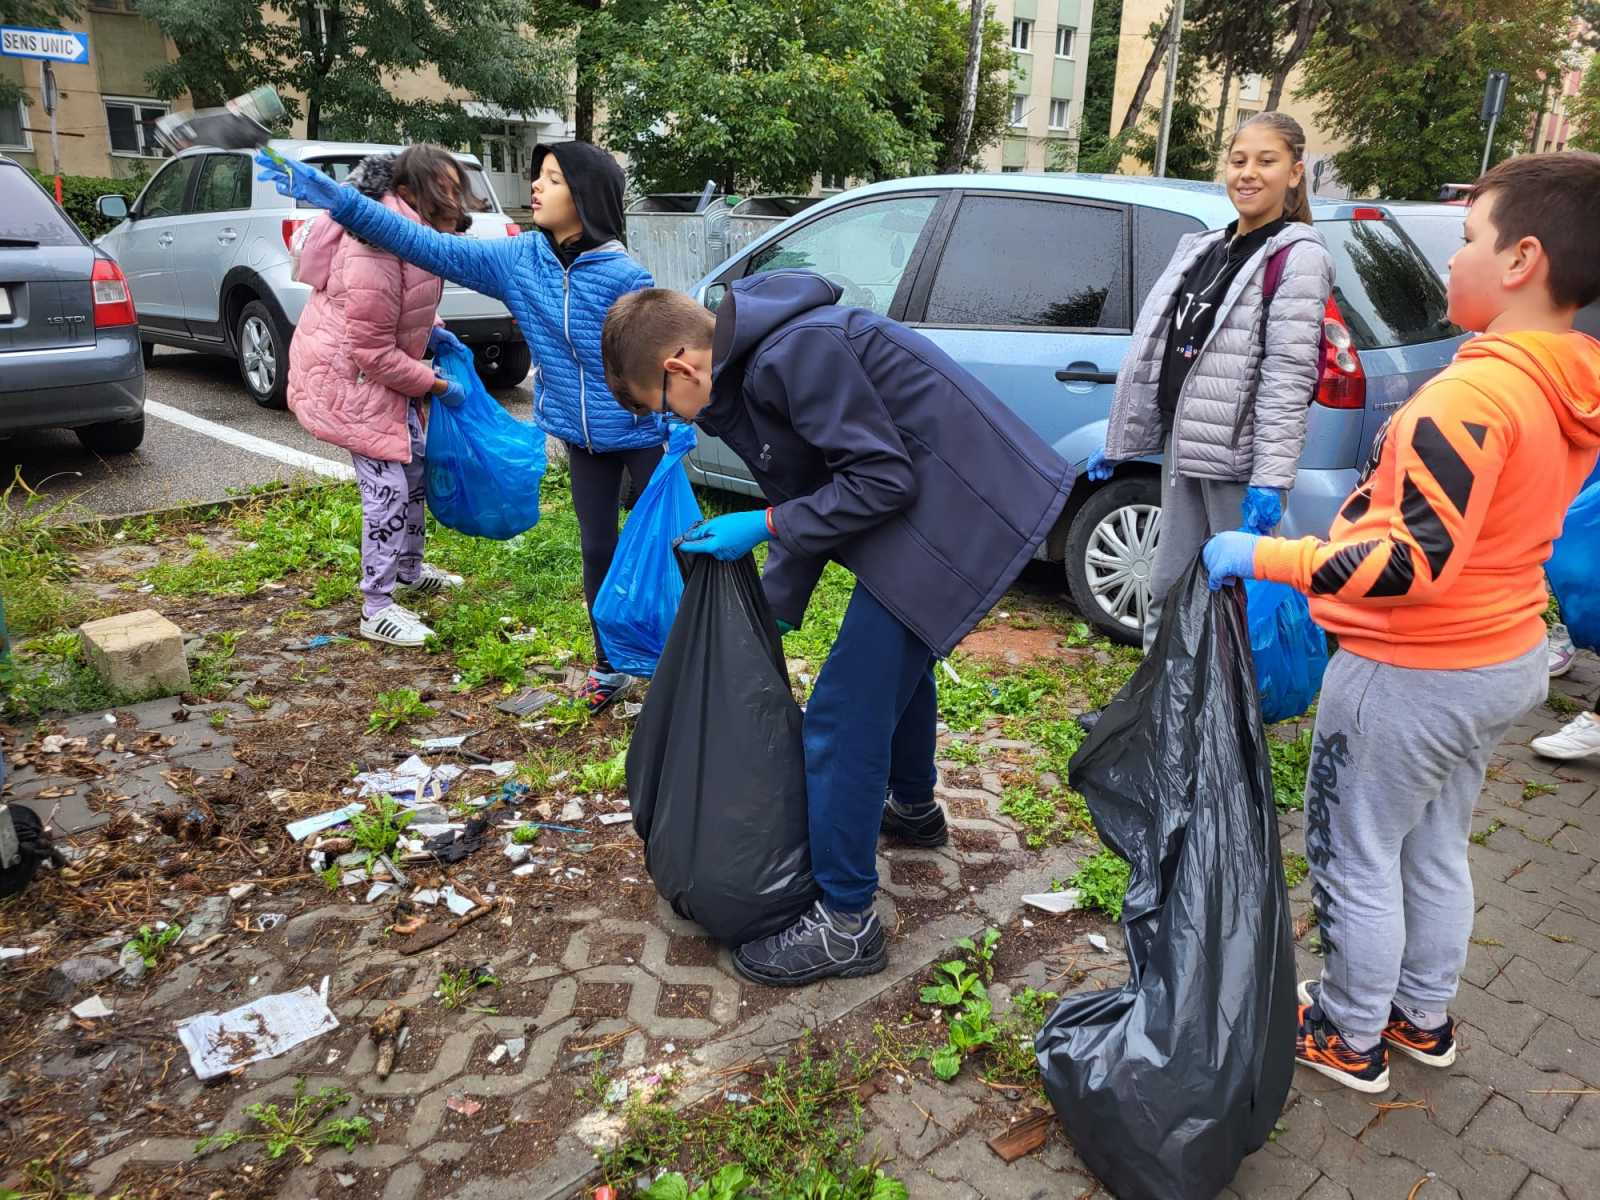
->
xmin=288 ymin=146 xmax=474 ymax=646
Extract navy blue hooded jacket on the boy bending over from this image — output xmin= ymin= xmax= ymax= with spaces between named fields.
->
xmin=701 ymin=270 xmax=1072 ymax=656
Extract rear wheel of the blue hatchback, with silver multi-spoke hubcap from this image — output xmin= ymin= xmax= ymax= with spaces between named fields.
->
xmin=1066 ymin=475 xmax=1162 ymax=646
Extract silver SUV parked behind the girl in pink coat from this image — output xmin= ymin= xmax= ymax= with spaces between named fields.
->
xmin=94 ymin=139 xmax=530 ymax=408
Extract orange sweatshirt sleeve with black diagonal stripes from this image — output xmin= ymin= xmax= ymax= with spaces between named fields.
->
xmin=1256 ymin=381 xmax=1515 ymax=608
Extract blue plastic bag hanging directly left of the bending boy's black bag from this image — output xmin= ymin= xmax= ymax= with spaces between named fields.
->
xmin=594 ymin=422 xmax=701 ymax=678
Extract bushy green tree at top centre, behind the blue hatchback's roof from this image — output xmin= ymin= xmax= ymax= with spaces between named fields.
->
xmin=597 ymin=0 xmax=939 ymax=192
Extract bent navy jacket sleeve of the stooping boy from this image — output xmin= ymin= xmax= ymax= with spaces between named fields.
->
xmin=746 ymin=326 xmax=917 ymax=557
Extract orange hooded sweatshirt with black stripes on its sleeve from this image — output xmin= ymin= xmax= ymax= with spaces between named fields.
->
xmin=1256 ymin=333 xmax=1600 ymax=670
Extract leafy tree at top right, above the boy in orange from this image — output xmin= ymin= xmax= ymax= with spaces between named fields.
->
xmin=1301 ymin=0 xmax=1573 ymax=200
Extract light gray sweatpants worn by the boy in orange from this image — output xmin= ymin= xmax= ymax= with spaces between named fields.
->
xmin=1306 ymin=642 xmax=1549 ymax=1045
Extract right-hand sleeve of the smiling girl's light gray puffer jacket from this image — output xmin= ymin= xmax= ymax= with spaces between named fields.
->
xmin=1250 ymin=242 xmax=1333 ymax=491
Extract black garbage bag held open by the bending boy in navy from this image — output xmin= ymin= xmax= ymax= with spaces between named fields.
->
xmin=627 ymin=554 xmax=819 ymax=946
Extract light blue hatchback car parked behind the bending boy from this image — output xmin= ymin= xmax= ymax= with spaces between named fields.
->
xmin=690 ymin=174 xmax=1462 ymax=643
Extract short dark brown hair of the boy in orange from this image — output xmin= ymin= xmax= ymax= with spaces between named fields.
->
xmin=1472 ymin=150 xmax=1600 ymax=309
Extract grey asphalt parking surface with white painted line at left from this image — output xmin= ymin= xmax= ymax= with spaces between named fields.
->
xmin=0 ymin=347 xmax=533 ymax=520
